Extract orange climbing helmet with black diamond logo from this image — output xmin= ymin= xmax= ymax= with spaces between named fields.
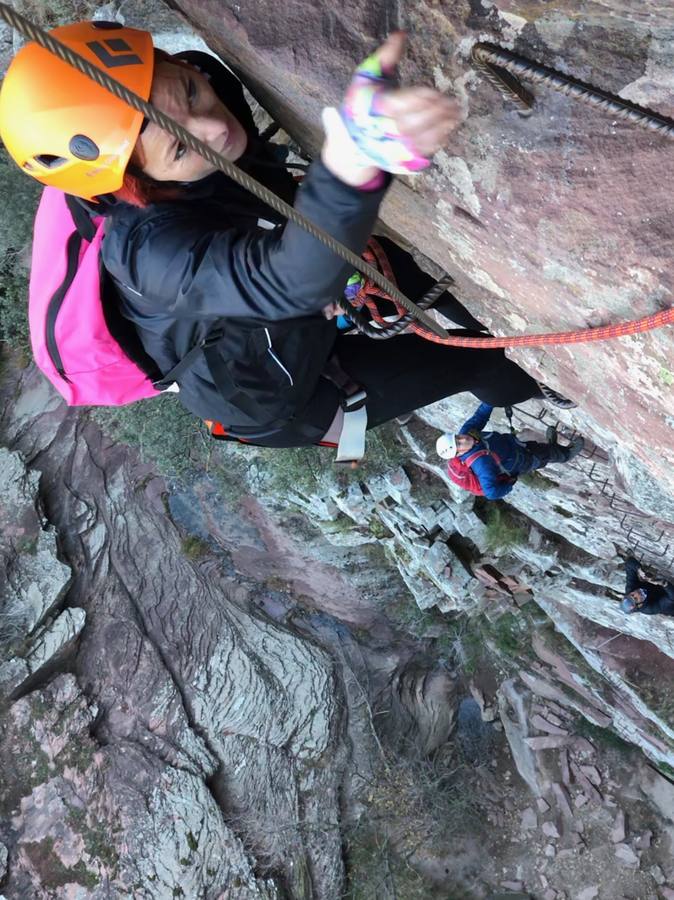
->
xmin=0 ymin=22 xmax=154 ymax=200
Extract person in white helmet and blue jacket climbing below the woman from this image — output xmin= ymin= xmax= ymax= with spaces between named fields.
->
xmin=436 ymin=403 xmax=584 ymax=500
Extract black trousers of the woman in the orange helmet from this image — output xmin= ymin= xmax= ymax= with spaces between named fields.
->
xmin=256 ymin=238 xmax=541 ymax=447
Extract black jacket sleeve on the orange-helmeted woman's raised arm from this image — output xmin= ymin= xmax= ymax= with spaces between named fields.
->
xmin=117 ymin=160 xmax=390 ymax=321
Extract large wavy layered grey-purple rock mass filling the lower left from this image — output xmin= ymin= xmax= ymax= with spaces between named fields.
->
xmin=0 ymin=372 xmax=462 ymax=900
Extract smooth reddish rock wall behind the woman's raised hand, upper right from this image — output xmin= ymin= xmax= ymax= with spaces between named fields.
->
xmin=169 ymin=0 xmax=674 ymax=506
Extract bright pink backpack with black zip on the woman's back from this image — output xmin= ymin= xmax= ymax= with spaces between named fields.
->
xmin=28 ymin=187 xmax=160 ymax=406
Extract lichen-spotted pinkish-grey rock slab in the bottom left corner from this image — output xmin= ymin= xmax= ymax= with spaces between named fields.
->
xmin=0 ymin=675 xmax=276 ymax=898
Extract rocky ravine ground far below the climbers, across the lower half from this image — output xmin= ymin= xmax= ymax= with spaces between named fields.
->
xmin=0 ymin=356 xmax=674 ymax=900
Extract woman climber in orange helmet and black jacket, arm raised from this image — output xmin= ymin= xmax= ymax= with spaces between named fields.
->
xmin=0 ymin=22 xmax=564 ymax=458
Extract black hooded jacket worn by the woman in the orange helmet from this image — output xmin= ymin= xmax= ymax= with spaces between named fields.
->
xmin=102 ymin=53 xmax=390 ymax=436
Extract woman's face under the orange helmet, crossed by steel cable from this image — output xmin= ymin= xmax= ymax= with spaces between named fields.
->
xmin=133 ymin=60 xmax=248 ymax=181
